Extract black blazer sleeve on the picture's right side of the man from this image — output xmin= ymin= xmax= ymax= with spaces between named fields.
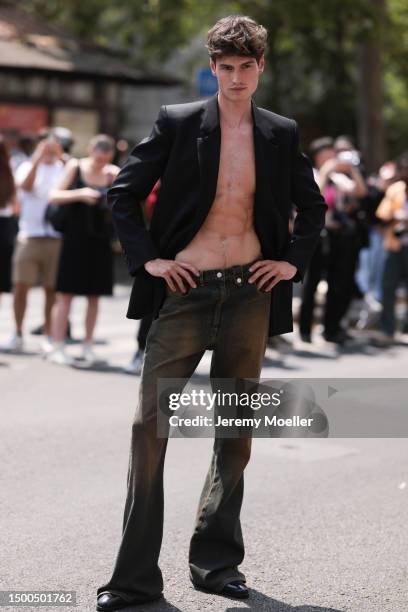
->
xmin=282 ymin=121 xmax=327 ymax=282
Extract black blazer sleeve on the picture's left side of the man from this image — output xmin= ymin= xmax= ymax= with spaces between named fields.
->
xmin=108 ymin=106 xmax=171 ymax=276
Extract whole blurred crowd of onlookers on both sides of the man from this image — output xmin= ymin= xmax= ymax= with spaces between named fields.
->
xmin=0 ymin=127 xmax=408 ymax=374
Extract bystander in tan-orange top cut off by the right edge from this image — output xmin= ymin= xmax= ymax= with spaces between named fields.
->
xmin=376 ymin=151 xmax=408 ymax=344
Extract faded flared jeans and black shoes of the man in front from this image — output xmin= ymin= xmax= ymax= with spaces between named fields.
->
xmin=98 ymin=262 xmax=271 ymax=601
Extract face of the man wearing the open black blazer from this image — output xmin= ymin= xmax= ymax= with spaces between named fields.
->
xmin=210 ymin=55 xmax=265 ymax=102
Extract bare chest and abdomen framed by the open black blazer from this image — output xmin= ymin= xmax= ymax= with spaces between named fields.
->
xmin=175 ymin=115 xmax=261 ymax=270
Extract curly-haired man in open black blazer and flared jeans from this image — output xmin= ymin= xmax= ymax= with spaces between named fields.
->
xmin=97 ymin=15 xmax=326 ymax=611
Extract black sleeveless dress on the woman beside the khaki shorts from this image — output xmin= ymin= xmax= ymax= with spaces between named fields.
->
xmin=56 ymin=167 xmax=113 ymax=295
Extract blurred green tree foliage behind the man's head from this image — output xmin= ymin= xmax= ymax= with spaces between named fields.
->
xmin=15 ymin=0 xmax=408 ymax=160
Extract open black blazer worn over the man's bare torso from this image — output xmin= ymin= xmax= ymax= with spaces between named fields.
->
xmin=108 ymin=95 xmax=327 ymax=335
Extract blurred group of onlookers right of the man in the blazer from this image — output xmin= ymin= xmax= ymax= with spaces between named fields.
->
xmin=299 ymin=136 xmax=408 ymax=345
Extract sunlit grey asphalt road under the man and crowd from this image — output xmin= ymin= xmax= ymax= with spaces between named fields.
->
xmin=0 ymin=286 xmax=408 ymax=612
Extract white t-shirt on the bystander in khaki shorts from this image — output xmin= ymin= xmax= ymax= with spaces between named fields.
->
xmin=15 ymin=160 xmax=64 ymax=238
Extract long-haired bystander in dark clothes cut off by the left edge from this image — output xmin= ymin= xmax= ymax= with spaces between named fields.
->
xmin=0 ymin=136 xmax=17 ymax=314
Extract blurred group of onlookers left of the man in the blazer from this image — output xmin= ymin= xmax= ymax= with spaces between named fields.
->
xmin=0 ymin=127 xmax=119 ymax=365
